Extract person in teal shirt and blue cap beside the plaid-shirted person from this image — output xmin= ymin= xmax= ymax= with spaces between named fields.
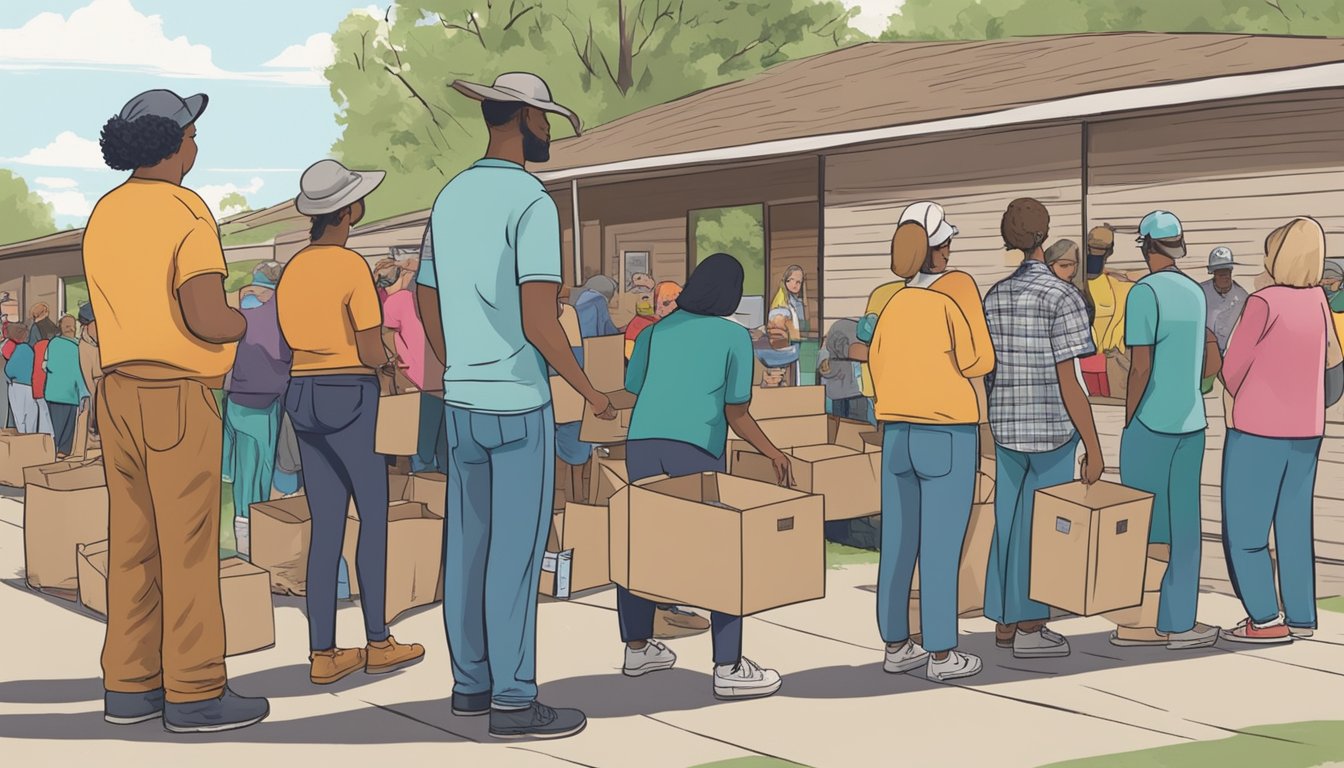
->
xmin=1111 ymin=211 xmax=1222 ymax=651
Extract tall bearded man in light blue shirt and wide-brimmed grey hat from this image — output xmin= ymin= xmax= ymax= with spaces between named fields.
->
xmin=417 ymin=73 xmax=616 ymax=738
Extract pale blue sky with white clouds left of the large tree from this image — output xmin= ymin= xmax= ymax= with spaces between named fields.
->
xmin=0 ymin=0 xmax=382 ymax=226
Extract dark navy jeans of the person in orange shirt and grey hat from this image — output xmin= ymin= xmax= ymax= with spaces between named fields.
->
xmin=285 ymin=375 xmax=387 ymax=651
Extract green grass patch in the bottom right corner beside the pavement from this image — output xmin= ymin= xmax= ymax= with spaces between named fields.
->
xmin=1046 ymin=720 xmax=1344 ymax=768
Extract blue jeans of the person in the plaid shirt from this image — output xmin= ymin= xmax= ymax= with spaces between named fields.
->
xmin=985 ymin=434 xmax=1079 ymax=624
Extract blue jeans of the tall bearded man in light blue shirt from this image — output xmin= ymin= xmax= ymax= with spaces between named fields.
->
xmin=444 ymin=405 xmax=555 ymax=709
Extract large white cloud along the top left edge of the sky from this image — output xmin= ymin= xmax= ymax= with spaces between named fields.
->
xmin=0 ymin=0 xmax=336 ymax=85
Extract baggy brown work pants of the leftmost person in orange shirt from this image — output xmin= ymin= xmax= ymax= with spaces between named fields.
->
xmin=98 ymin=371 xmax=226 ymax=703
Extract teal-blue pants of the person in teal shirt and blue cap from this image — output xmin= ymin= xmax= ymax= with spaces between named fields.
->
xmin=1120 ymin=418 xmax=1204 ymax=635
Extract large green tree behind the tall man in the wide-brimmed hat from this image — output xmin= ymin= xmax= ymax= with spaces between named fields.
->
xmin=327 ymin=0 xmax=864 ymax=219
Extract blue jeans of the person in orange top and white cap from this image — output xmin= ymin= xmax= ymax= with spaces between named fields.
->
xmin=878 ymin=421 xmax=980 ymax=654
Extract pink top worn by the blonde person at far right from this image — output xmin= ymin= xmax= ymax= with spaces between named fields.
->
xmin=1223 ymin=285 xmax=1333 ymax=438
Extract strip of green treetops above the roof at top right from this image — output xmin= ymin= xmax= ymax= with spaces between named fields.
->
xmin=882 ymin=0 xmax=1344 ymax=40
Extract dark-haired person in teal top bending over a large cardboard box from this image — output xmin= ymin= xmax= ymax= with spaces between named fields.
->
xmin=617 ymin=253 xmax=792 ymax=699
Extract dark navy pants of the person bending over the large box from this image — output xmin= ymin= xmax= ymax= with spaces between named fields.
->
xmin=616 ymin=440 xmax=742 ymax=666
